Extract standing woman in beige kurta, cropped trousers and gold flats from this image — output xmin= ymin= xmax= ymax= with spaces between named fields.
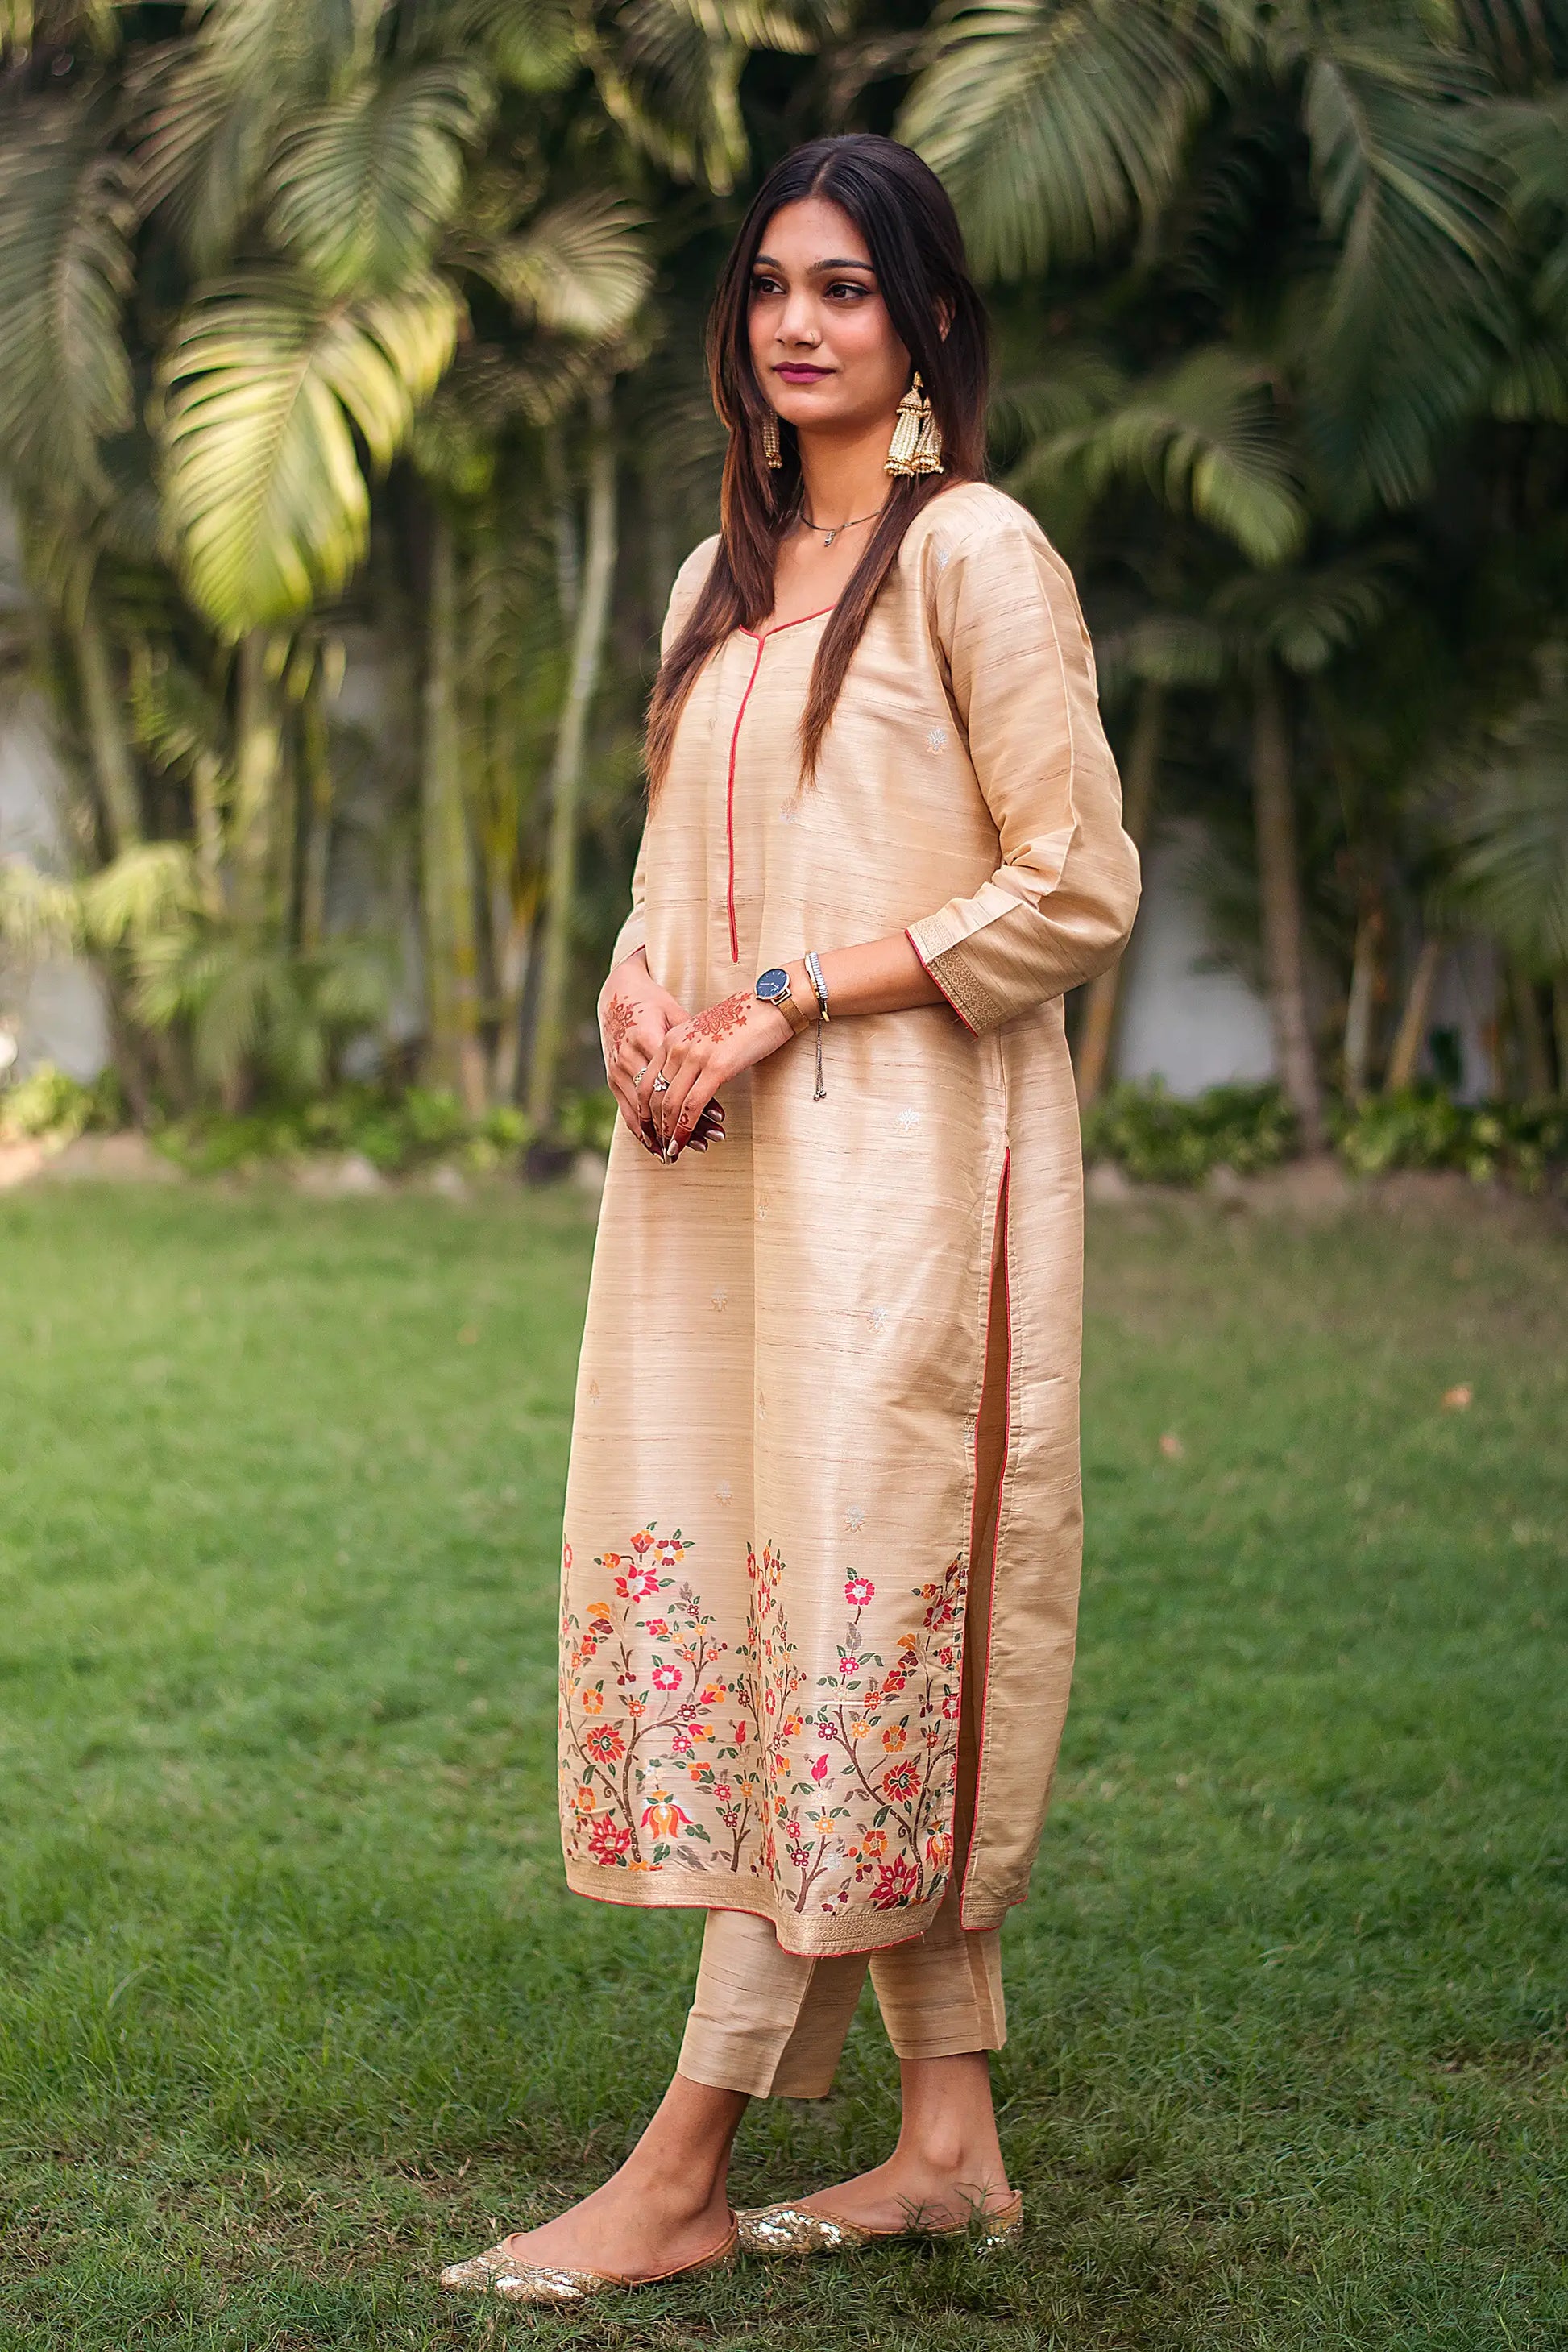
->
xmin=442 ymin=136 xmax=1138 ymax=2300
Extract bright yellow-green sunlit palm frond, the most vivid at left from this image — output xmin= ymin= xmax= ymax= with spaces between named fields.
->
xmin=160 ymin=268 xmax=458 ymax=635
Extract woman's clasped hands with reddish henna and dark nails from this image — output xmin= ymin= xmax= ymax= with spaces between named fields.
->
xmin=599 ymin=948 xmax=792 ymax=1162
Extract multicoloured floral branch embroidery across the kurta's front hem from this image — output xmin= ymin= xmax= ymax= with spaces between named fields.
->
xmin=562 ymin=1524 xmax=966 ymax=1914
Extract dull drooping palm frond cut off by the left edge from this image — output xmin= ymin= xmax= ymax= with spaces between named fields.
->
xmin=0 ymin=106 xmax=131 ymax=504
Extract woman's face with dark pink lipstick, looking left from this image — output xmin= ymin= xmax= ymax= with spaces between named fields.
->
xmin=748 ymin=195 xmax=910 ymax=433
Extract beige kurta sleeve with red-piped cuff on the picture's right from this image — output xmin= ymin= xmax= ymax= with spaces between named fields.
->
xmin=910 ymin=510 xmax=1138 ymax=1035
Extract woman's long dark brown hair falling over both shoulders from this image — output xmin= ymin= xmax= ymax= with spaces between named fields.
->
xmin=646 ymin=131 xmax=987 ymax=795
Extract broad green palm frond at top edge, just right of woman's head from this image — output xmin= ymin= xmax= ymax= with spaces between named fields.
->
xmin=898 ymin=0 xmax=1209 ymax=277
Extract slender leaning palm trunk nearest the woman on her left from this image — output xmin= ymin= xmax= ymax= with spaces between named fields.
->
xmin=529 ymin=386 xmax=616 ymax=1136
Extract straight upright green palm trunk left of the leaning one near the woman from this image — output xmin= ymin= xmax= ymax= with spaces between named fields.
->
xmin=421 ymin=506 xmax=484 ymax=1118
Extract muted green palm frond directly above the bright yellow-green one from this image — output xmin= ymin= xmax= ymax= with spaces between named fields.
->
xmin=268 ymin=59 xmax=492 ymax=294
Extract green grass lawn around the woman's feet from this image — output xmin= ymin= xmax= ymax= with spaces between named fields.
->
xmin=0 ymin=1188 xmax=1568 ymax=2352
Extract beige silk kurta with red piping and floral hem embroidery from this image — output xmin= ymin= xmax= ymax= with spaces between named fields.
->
xmin=559 ymin=484 xmax=1138 ymax=1955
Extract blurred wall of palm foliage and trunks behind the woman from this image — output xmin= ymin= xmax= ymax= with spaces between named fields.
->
xmin=0 ymin=0 xmax=1568 ymax=1147
